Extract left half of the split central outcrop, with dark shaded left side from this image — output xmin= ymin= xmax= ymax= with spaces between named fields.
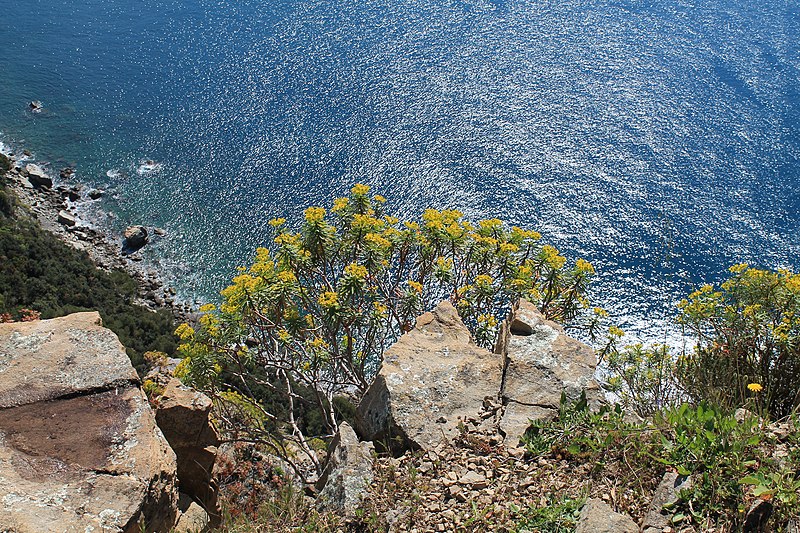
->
xmin=356 ymin=301 xmax=502 ymax=453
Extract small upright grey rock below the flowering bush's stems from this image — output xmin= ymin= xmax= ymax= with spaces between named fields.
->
xmin=317 ymin=422 xmax=374 ymax=516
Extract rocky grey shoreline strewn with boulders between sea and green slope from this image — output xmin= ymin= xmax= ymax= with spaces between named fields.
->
xmin=6 ymin=150 xmax=194 ymax=321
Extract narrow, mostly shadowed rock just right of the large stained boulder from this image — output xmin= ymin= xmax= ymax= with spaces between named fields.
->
xmin=156 ymin=378 xmax=220 ymax=526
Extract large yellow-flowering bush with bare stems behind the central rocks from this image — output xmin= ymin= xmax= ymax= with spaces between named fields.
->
xmin=178 ymin=185 xmax=593 ymax=478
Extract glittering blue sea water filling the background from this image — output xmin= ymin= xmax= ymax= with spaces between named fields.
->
xmin=0 ymin=0 xmax=800 ymax=336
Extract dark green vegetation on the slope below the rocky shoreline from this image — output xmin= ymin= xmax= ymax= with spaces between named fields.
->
xmin=0 ymin=166 xmax=176 ymax=369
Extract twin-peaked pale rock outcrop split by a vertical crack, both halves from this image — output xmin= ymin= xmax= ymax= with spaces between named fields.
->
xmin=356 ymin=300 xmax=603 ymax=452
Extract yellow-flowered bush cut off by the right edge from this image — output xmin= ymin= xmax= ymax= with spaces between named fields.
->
xmin=677 ymin=264 xmax=800 ymax=419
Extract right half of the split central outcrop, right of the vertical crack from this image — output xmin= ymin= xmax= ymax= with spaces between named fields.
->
xmin=495 ymin=300 xmax=603 ymax=446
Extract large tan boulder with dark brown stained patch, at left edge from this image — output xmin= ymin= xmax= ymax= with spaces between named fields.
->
xmin=0 ymin=313 xmax=178 ymax=533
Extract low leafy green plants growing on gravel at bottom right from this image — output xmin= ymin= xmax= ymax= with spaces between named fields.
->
xmin=523 ymin=398 xmax=800 ymax=531
